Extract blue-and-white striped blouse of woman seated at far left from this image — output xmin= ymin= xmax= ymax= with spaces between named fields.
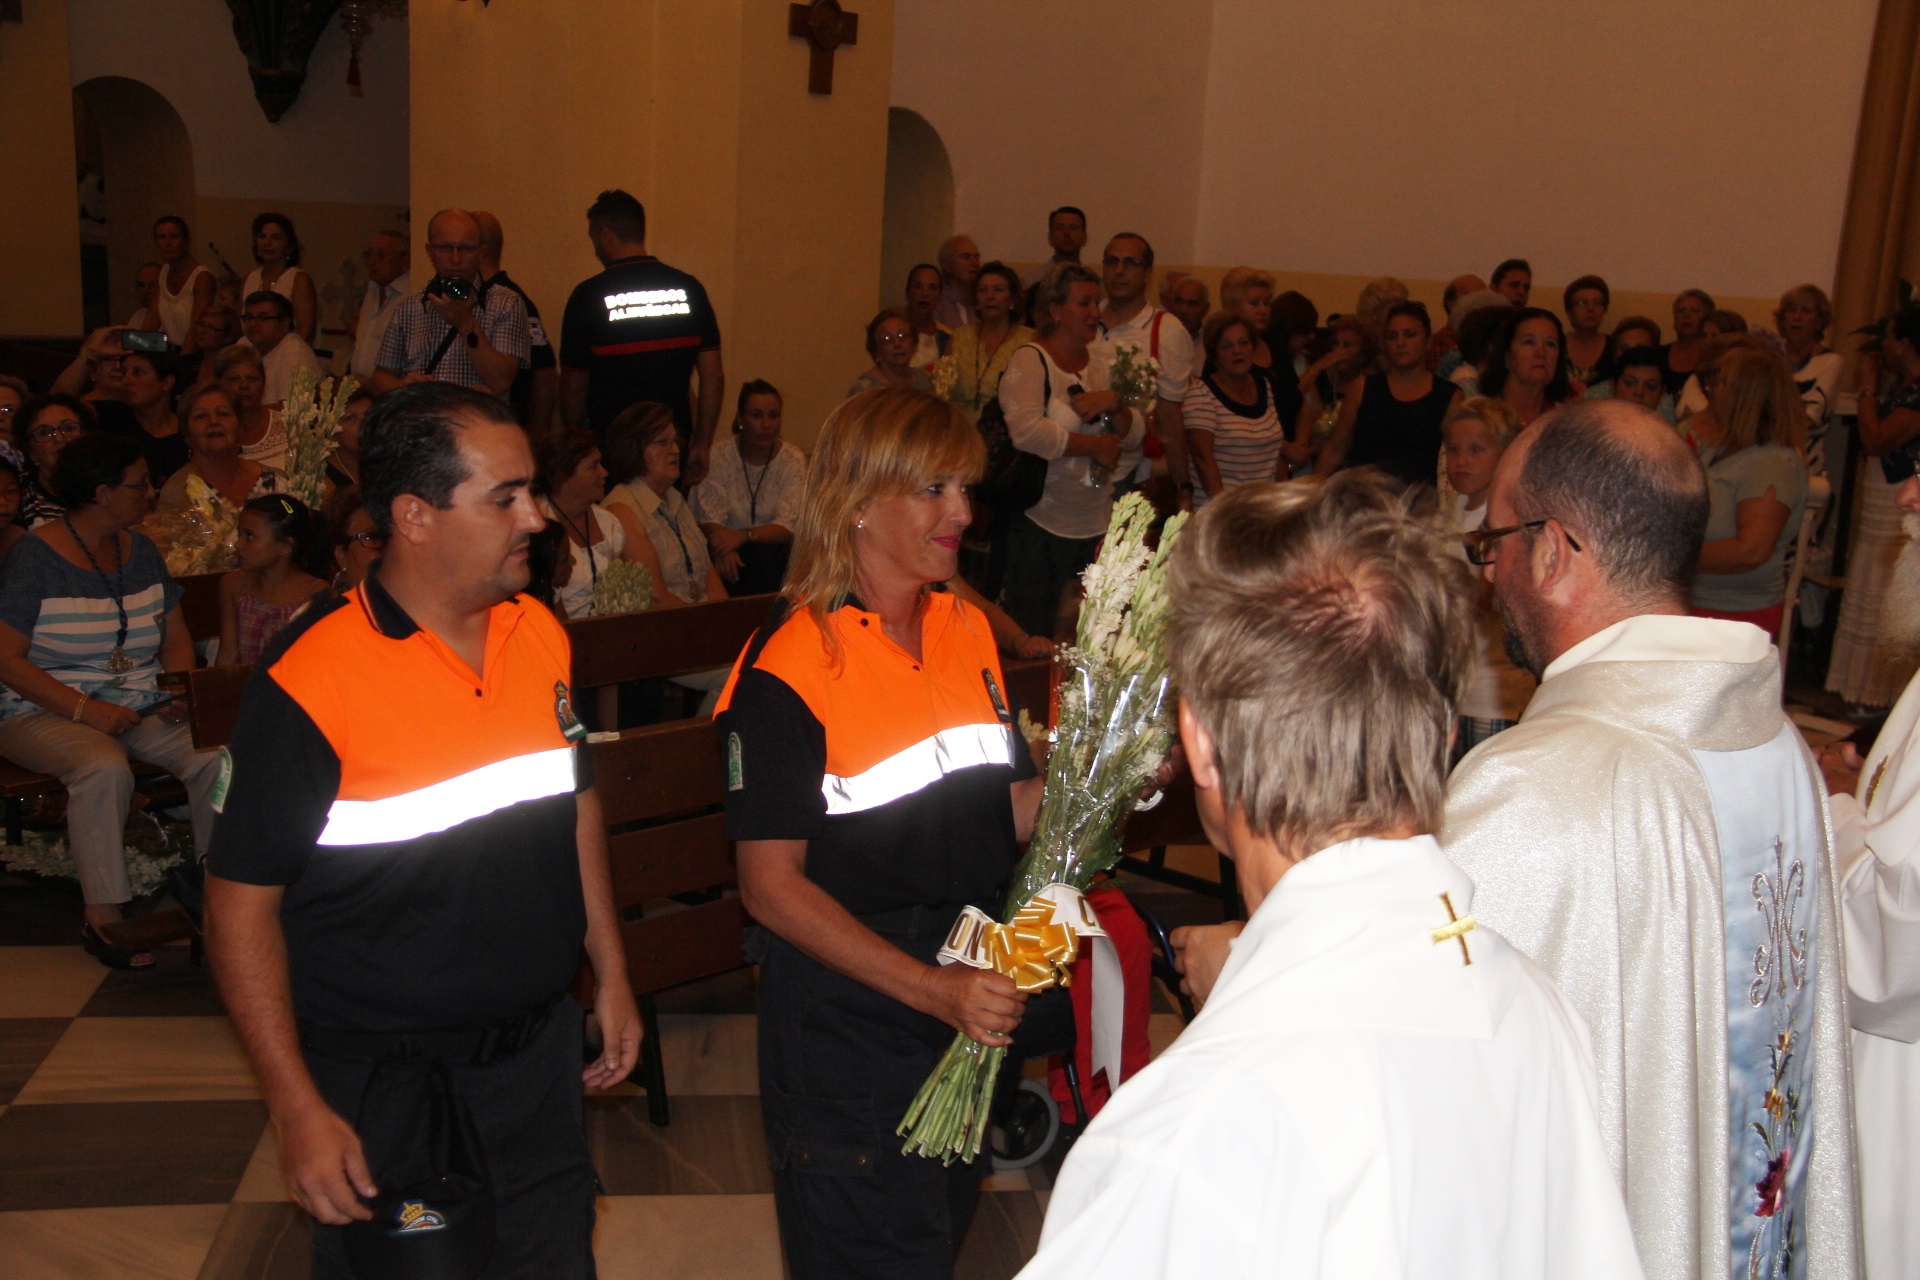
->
xmin=0 ymin=533 xmax=180 ymax=720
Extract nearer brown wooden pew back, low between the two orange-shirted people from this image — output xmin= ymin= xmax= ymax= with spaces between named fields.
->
xmin=588 ymin=725 xmax=747 ymax=1125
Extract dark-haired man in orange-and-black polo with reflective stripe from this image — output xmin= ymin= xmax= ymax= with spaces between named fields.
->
xmin=207 ymin=384 xmax=639 ymax=1280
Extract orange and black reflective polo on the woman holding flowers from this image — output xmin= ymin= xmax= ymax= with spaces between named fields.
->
xmin=716 ymin=591 xmax=1035 ymax=915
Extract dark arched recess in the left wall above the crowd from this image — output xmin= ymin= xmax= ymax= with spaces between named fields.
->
xmin=73 ymin=75 xmax=205 ymax=322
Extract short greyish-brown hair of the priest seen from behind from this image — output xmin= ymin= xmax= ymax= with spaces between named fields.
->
xmin=1167 ymin=470 xmax=1475 ymax=854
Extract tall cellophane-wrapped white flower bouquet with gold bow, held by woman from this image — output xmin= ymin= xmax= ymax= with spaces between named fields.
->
xmin=897 ymin=493 xmax=1187 ymax=1163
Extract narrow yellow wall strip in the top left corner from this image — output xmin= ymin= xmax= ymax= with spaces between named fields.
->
xmin=0 ymin=0 xmax=81 ymax=338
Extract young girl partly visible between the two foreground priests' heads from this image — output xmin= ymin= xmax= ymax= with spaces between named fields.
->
xmin=1442 ymin=395 xmax=1536 ymax=762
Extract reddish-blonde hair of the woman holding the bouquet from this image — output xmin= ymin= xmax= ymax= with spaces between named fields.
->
xmin=785 ymin=388 xmax=987 ymax=647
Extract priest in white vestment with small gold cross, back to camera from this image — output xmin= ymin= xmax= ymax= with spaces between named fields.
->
xmin=1021 ymin=472 xmax=1642 ymax=1280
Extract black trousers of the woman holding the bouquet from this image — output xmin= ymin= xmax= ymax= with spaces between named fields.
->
xmin=755 ymin=906 xmax=1073 ymax=1280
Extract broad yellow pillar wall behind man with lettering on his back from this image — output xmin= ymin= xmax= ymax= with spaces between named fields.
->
xmin=409 ymin=0 xmax=893 ymax=445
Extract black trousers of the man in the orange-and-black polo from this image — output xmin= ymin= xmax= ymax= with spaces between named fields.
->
xmin=305 ymin=998 xmax=599 ymax=1280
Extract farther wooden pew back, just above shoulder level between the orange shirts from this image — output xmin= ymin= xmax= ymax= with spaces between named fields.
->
xmin=566 ymin=595 xmax=778 ymax=731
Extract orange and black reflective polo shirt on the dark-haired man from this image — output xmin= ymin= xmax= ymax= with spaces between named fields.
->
xmin=207 ymin=574 xmax=586 ymax=1031
